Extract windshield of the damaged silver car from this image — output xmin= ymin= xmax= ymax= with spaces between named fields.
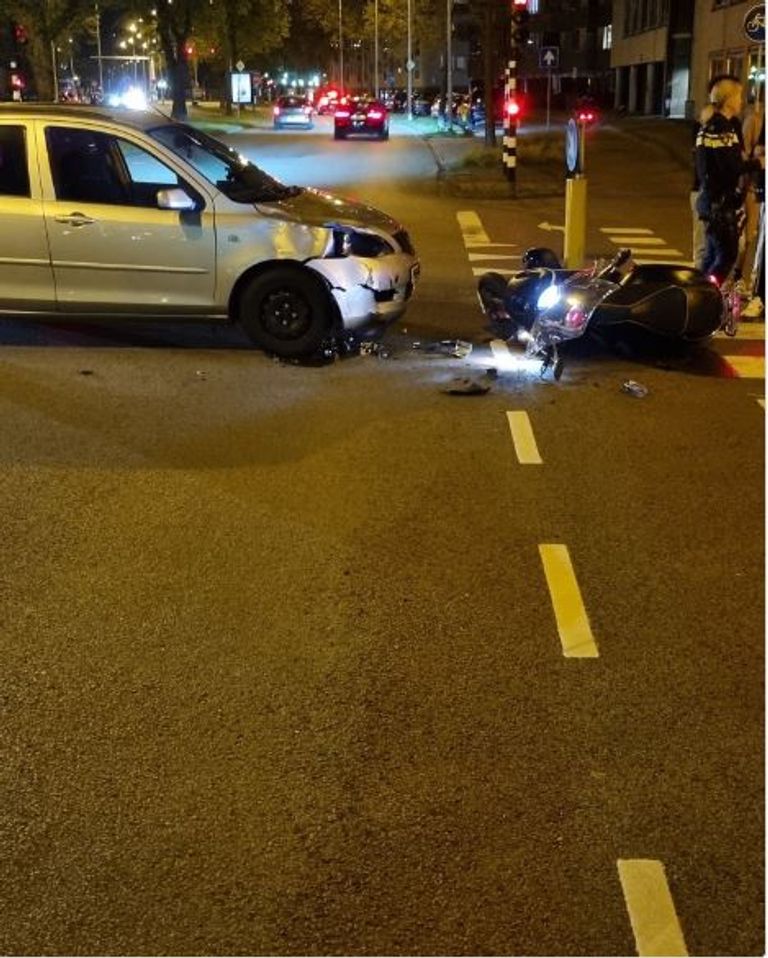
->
xmin=147 ymin=123 xmax=301 ymax=203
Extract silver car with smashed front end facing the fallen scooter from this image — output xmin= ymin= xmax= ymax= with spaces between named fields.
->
xmin=0 ymin=104 xmax=419 ymax=357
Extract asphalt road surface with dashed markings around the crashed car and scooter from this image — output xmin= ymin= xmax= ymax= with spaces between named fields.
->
xmin=0 ymin=116 xmax=765 ymax=955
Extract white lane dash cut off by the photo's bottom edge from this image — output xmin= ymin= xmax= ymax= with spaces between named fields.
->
xmin=618 ymin=859 xmax=688 ymax=958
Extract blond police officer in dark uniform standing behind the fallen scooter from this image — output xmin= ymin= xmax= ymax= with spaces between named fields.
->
xmin=696 ymin=76 xmax=765 ymax=286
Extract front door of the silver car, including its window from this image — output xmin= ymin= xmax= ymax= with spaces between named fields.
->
xmin=38 ymin=122 xmax=216 ymax=315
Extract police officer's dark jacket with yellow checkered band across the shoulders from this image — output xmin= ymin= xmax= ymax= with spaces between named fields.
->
xmin=696 ymin=112 xmax=760 ymax=219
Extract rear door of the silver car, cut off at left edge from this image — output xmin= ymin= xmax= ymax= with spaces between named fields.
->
xmin=0 ymin=117 xmax=56 ymax=312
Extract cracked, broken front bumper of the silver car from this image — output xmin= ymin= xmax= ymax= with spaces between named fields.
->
xmin=306 ymin=253 xmax=420 ymax=332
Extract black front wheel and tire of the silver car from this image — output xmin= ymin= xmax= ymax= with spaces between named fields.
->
xmin=239 ymin=266 xmax=333 ymax=359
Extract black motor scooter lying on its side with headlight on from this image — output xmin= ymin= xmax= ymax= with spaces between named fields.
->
xmin=478 ymin=248 xmax=726 ymax=379
